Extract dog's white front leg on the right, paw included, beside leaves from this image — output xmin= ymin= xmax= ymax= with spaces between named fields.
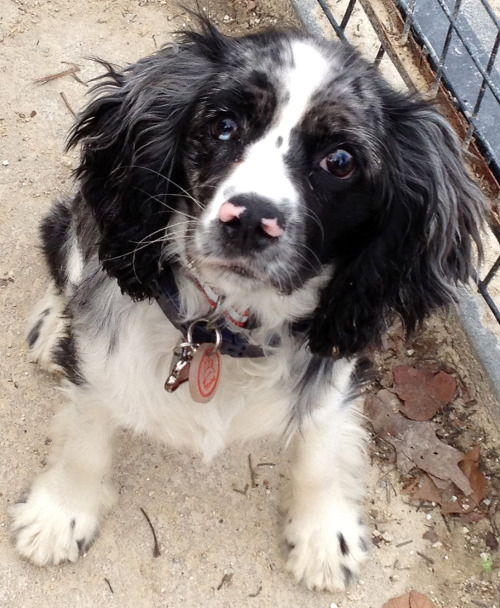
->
xmin=285 ymin=358 xmax=368 ymax=590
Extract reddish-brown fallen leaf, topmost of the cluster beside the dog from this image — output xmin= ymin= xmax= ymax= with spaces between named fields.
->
xmin=392 ymin=365 xmax=457 ymax=422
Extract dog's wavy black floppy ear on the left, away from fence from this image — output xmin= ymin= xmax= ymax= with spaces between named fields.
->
xmin=68 ymin=23 xmax=223 ymax=299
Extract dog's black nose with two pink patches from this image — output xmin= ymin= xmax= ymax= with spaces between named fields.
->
xmin=219 ymin=194 xmax=285 ymax=253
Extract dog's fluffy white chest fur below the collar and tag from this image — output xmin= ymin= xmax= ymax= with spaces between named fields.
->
xmin=76 ymin=296 xmax=291 ymax=460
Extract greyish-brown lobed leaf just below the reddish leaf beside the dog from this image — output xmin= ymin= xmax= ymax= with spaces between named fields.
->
xmin=365 ymin=389 xmax=472 ymax=496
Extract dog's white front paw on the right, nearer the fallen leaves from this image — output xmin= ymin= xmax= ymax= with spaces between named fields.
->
xmin=284 ymin=505 xmax=368 ymax=591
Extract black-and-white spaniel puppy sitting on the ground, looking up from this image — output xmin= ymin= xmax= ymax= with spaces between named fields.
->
xmin=13 ymin=20 xmax=484 ymax=589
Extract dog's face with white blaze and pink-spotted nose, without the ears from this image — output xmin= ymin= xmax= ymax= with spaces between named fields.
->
xmin=182 ymin=36 xmax=385 ymax=293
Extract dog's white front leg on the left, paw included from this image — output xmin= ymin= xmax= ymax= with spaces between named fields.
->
xmin=12 ymin=388 xmax=114 ymax=566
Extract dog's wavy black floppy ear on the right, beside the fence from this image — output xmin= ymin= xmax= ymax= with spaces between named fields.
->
xmin=309 ymin=91 xmax=486 ymax=357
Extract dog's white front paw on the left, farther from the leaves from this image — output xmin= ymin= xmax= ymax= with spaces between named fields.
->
xmin=11 ymin=479 xmax=105 ymax=566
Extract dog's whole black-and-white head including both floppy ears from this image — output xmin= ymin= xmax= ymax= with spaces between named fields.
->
xmin=70 ymin=21 xmax=483 ymax=356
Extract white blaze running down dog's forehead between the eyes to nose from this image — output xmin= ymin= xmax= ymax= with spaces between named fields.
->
xmin=204 ymin=40 xmax=329 ymax=225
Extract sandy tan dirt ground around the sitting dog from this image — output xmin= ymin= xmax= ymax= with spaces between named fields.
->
xmin=0 ymin=0 xmax=500 ymax=608
